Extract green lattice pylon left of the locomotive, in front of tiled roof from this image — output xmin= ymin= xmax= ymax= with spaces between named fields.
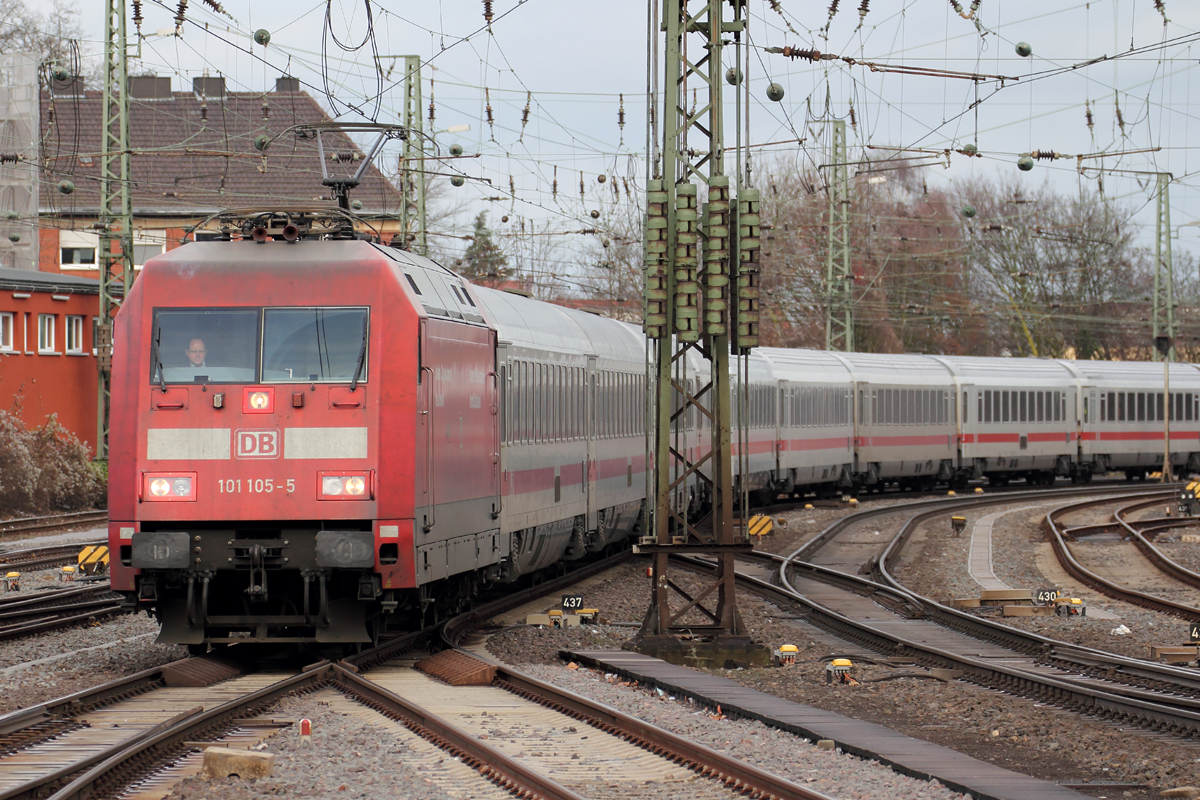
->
xmin=96 ymin=0 xmax=133 ymax=461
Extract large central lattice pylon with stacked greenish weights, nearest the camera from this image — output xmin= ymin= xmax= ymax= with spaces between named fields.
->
xmin=637 ymin=0 xmax=758 ymax=658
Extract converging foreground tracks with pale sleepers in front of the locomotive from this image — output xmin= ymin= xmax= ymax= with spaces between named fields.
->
xmin=0 ymin=554 xmax=828 ymax=800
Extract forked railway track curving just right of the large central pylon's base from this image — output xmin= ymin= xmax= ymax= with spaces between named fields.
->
xmin=672 ymin=489 xmax=1200 ymax=738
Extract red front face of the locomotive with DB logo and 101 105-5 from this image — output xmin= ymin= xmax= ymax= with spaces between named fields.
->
xmin=109 ymin=240 xmax=416 ymax=649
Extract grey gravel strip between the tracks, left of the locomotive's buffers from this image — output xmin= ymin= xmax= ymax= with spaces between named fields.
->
xmin=0 ymin=614 xmax=187 ymax=714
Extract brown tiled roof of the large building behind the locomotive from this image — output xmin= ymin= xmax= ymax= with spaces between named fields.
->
xmin=41 ymin=82 xmax=401 ymax=216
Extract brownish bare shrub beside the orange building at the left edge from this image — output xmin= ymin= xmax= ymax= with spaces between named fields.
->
xmin=0 ymin=411 xmax=104 ymax=513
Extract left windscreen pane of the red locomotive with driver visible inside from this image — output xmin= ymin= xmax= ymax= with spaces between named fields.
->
xmin=150 ymin=308 xmax=260 ymax=384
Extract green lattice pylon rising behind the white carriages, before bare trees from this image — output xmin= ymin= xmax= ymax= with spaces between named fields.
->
xmin=826 ymin=120 xmax=854 ymax=353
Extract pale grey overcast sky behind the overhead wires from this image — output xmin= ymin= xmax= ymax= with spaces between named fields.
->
xmin=68 ymin=0 xmax=1200 ymax=260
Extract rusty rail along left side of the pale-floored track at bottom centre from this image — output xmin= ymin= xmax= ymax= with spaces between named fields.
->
xmin=333 ymin=664 xmax=583 ymax=800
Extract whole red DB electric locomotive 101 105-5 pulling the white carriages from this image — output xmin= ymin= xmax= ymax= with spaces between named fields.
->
xmin=109 ymin=218 xmax=508 ymax=649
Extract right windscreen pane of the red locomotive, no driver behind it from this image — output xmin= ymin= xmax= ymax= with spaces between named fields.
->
xmin=263 ymin=308 xmax=368 ymax=383
